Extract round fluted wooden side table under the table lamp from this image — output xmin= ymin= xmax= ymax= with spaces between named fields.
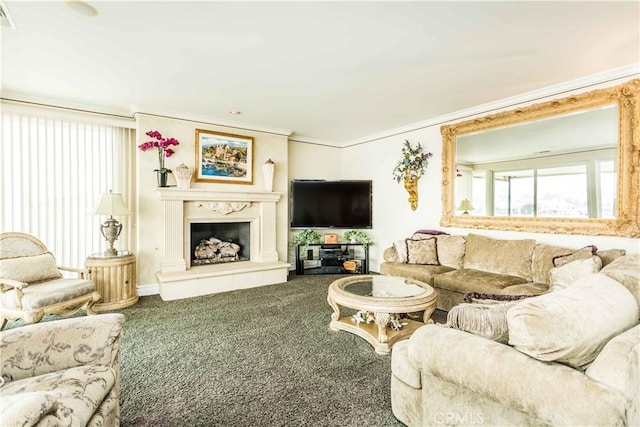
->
xmin=85 ymin=251 xmax=138 ymax=311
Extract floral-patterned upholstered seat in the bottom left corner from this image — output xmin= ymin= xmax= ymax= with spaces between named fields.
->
xmin=0 ymin=314 xmax=125 ymax=426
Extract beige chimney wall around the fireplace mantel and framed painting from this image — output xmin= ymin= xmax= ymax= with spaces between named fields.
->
xmin=136 ymin=114 xmax=289 ymax=286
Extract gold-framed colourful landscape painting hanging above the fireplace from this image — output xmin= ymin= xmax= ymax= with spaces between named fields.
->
xmin=195 ymin=129 xmax=253 ymax=184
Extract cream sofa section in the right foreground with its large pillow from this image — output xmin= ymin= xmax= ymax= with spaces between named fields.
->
xmin=391 ymin=255 xmax=640 ymax=426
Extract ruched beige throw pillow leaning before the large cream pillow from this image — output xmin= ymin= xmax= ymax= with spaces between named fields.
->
xmin=447 ymin=300 xmax=517 ymax=344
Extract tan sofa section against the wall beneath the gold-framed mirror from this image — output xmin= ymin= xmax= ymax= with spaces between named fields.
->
xmin=380 ymin=233 xmax=625 ymax=311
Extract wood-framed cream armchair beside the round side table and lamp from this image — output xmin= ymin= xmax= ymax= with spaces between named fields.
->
xmin=0 ymin=233 xmax=100 ymax=329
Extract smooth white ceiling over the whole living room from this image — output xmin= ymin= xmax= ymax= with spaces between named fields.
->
xmin=1 ymin=0 xmax=640 ymax=145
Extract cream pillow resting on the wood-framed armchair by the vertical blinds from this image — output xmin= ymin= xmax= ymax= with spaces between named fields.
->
xmin=0 ymin=252 xmax=62 ymax=283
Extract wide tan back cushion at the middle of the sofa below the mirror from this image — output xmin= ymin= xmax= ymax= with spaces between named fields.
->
xmin=464 ymin=234 xmax=536 ymax=281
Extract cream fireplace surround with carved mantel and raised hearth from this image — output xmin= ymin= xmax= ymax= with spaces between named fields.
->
xmin=156 ymin=187 xmax=289 ymax=300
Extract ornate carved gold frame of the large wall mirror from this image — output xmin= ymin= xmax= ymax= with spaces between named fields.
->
xmin=440 ymin=79 xmax=640 ymax=237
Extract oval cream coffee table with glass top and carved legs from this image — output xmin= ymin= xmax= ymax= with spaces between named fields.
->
xmin=327 ymin=276 xmax=438 ymax=354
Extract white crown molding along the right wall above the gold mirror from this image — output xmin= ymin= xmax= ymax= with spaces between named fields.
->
xmin=340 ymin=63 xmax=640 ymax=148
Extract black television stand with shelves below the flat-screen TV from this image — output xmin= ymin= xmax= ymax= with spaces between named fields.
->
xmin=296 ymin=243 xmax=369 ymax=275
